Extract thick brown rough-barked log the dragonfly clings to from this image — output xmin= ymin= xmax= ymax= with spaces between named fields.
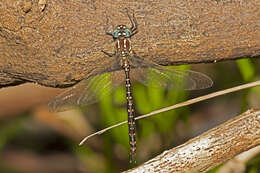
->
xmin=0 ymin=0 xmax=260 ymax=87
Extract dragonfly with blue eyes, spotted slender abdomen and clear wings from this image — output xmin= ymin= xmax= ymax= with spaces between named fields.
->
xmin=48 ymin=9 xmax=213 ymax=163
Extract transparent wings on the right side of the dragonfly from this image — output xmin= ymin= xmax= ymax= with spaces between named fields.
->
xmin=129 ymin=56 xmax=213 ymax=90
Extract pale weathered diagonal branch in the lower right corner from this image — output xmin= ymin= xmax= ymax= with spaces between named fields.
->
xmin=123 ymin=110 xmax=260 ymax=173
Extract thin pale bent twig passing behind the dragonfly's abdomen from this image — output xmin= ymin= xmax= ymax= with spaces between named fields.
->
xmin=79 ymin=81 xmax=260 ymax=145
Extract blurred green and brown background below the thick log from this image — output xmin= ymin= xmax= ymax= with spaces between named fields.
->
xmin=0 ymin=59 xmax=260 ymax=173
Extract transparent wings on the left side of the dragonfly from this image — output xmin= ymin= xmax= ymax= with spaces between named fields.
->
xmin=48 ymin=57 xmax=124 ymax=112
